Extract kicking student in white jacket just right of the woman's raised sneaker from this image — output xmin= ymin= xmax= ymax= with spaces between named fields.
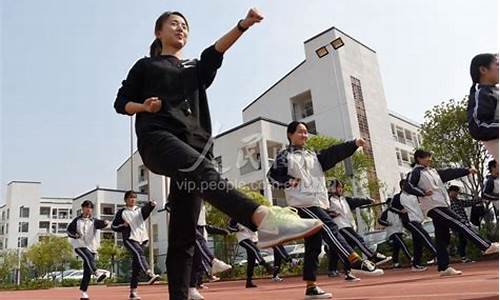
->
xmin=267 ymin=121 xmax=384 ymax=299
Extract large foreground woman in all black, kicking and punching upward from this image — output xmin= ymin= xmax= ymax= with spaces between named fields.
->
xmin=114 ymin=9 xmax=321 ymax=300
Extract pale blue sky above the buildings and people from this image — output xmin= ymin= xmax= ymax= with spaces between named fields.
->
xmin=0 ymin=0 xmax=498 ymax=202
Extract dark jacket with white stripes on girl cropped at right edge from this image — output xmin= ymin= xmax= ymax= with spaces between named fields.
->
xmin=467 ymin=85 xmax=498 ymax=141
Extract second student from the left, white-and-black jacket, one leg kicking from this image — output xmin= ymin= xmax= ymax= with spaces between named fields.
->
xmin=111 ymin=191 xmax=160 ymax=300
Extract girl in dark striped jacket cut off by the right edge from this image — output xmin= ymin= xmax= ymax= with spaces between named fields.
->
xmin=467 ymin=53 xmax=498 ymax=160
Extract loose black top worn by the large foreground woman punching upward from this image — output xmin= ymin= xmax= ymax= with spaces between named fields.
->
xmin=114 ymin=46 xmax=223 ymax=149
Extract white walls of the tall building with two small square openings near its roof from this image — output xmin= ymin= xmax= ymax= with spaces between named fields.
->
xmin=243 ymin=29 xmax=399 ymax=198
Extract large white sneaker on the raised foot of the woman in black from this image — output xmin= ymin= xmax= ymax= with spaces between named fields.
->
xmin=257 ymin=206 xmax=323 ymax=248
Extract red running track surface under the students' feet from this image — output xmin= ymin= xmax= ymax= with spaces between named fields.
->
xmin=0 ymin=260 xmax=499 ymax=300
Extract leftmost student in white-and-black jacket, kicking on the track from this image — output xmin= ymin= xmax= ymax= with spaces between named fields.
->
xmin=66 ymin=200 xmax=110 ymax=300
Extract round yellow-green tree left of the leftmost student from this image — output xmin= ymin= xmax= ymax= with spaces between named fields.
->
xmin=26 ymin=235 xmax=74 ymax=277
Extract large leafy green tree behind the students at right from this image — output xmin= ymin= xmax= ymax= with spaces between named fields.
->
xmin=420 ymin=97 xmax=488 ymax=197
